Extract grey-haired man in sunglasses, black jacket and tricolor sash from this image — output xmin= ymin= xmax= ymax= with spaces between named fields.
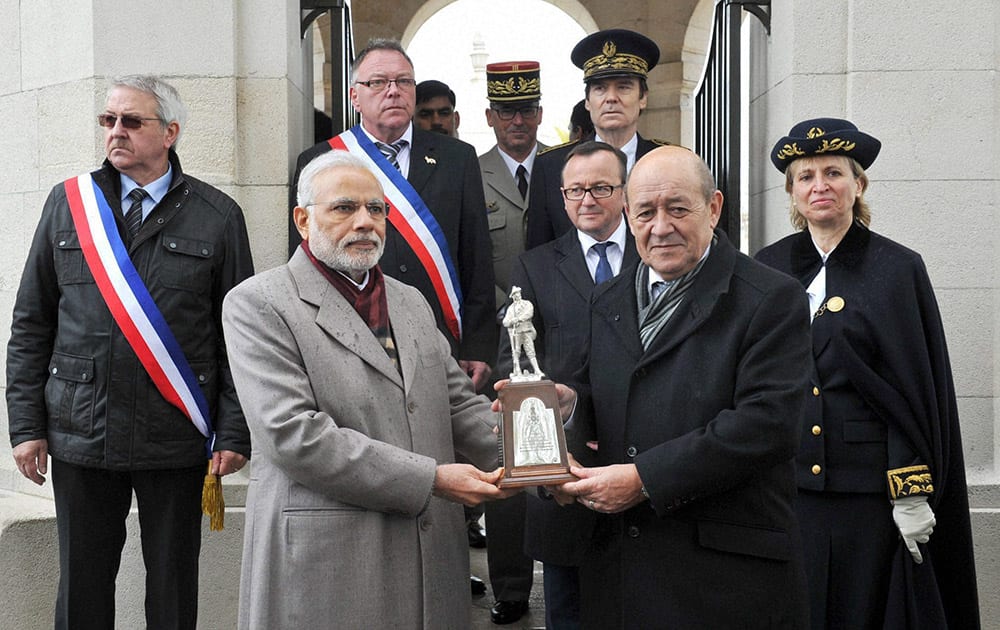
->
xmin=7 ymin=76 xmax=253 ymax=629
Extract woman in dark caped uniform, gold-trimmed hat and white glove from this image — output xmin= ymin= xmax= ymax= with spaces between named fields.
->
xmin=757 ymin=118 xmax=979 ymax=628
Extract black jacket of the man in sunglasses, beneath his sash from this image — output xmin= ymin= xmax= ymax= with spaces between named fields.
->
xmin=7 ymin=151 xmax=253 ymax=470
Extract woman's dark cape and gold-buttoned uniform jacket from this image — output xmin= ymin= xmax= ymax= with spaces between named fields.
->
xmin=757 ymin=223 xmax=979 ymax=628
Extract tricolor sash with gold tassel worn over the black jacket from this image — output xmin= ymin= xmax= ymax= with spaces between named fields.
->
xmin=63 ymin=173 xmax=215 ymax=454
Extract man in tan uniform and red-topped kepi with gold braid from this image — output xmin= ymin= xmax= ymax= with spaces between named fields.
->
xmin=479 ymin=61 xmax=544 ymax=624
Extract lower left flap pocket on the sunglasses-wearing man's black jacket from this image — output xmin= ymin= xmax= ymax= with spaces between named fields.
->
xmin=45 ymin=352 xmax=94 ymax=437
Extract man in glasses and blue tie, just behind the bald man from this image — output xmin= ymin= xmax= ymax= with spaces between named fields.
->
xmin=497 ymin=141 xmax=639 ymax=629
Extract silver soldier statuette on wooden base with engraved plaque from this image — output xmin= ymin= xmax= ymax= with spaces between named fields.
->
xmin=497 ymin=287 xmax=575 ymax=488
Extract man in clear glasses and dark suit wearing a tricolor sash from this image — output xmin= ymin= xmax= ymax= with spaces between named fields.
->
xmin=296 ymin=39 xmax=497 ymax=391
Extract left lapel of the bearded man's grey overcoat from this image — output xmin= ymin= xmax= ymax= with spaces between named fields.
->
xmin=288 ymin=254 xmax=403 ymax=387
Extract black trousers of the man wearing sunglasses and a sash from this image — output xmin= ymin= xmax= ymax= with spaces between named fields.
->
xmin=51 ymin=458 xmax=205 ymax=630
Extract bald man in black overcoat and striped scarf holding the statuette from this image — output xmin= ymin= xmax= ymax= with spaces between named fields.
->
xmin=553 ymin=147 xmax=811 ymax=629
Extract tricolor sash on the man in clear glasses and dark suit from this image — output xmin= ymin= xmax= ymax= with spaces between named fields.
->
xmin=329 ymin=125 xmax=462 ymax=341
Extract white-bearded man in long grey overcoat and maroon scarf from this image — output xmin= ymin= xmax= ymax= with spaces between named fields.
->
xmin=223 ymin=151 xmax=510 ymax=630
